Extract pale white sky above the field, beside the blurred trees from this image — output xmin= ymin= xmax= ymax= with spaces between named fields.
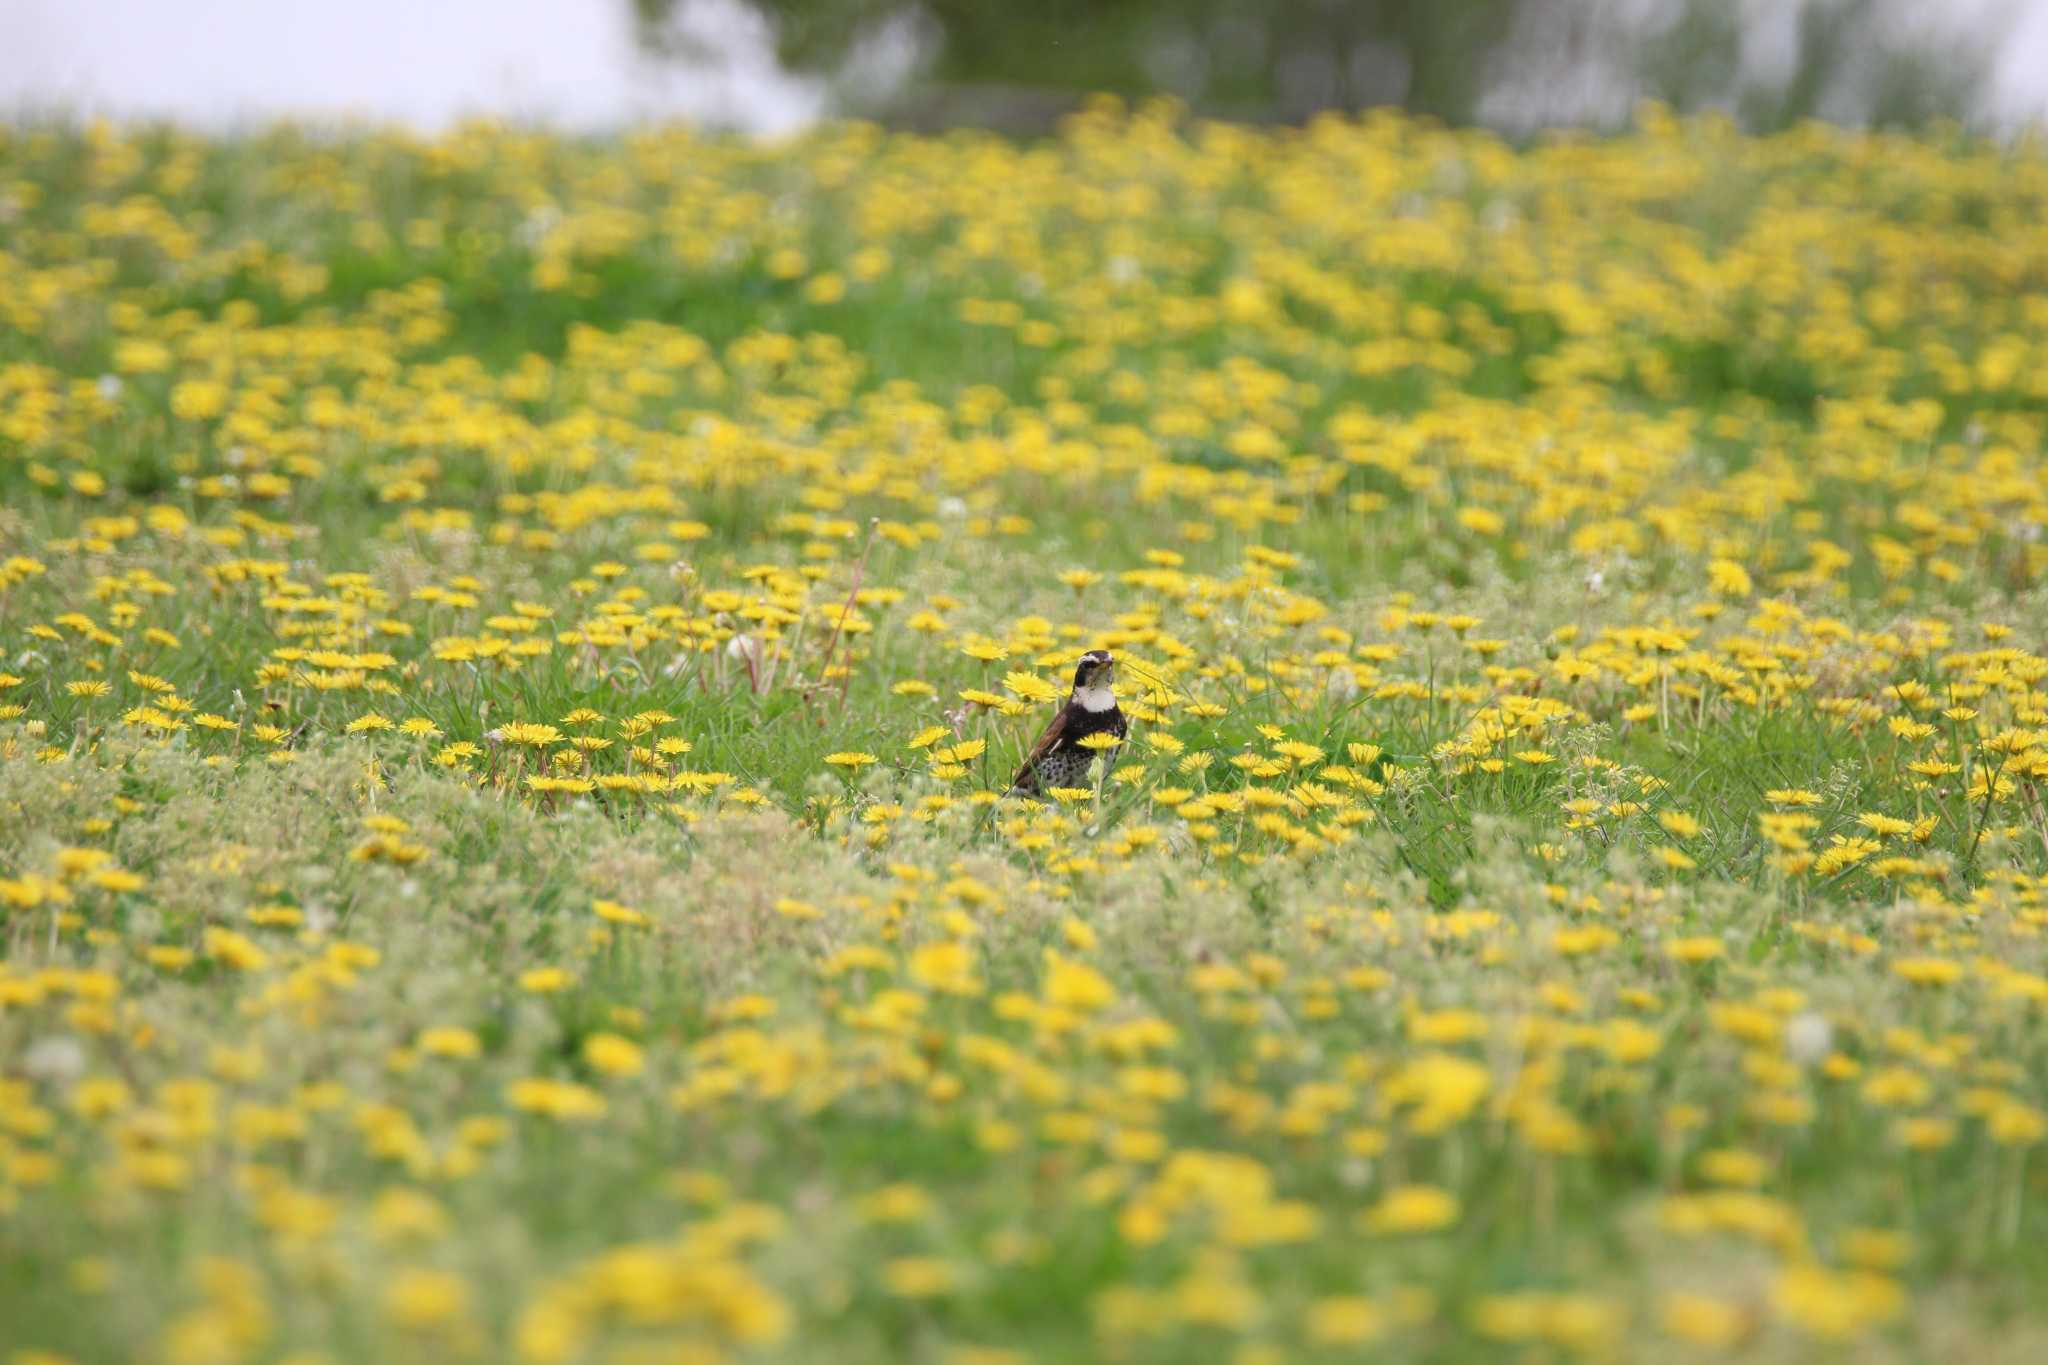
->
xmin=0 ymin=0 xmax=2048 ymax=133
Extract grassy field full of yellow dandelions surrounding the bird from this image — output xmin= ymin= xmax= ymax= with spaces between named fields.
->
xmin=0 ymin=104 xmax=2048 ymax=1365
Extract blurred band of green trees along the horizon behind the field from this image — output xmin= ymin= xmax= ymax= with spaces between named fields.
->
xmin=631 ymin=0 xmax=2009 ymax=131
